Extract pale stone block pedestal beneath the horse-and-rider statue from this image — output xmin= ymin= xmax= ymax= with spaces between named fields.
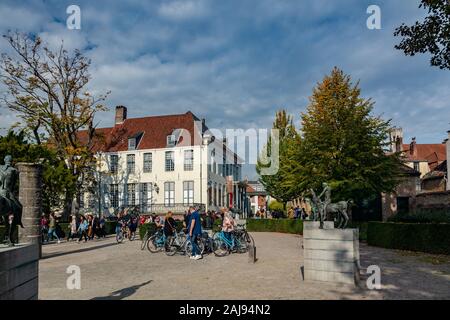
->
xmin=303 ymin=221 xmax=359 ymax=285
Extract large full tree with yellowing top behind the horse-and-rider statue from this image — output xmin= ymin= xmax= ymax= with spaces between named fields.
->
xmin=296 ymin=68 xmax=401 ymax=200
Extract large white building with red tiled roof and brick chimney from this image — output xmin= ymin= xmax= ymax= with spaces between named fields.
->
xmin=80 ymin=106 xmax=245 ymax=214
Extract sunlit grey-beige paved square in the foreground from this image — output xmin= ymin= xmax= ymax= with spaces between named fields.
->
xmin=39 ymin=233 xmax=450 ymax=300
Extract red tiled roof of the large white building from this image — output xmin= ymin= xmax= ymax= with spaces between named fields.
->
xmin=79 ymin=111 xmax=199 ymax=152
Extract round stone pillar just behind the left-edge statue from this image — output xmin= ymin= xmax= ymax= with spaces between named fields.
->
xmin=16 ymin=163 xmax=42 ymax=257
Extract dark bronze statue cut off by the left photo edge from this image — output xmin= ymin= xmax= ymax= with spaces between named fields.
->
xmin=0 ymin=155 xmax=23 ymax=245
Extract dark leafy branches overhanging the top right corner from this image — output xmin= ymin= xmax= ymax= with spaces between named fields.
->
xmin=394 ymin=0 xmax=450 ymax=69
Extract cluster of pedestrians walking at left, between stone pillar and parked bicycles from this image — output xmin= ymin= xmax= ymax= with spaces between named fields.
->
xmin=40 ymin=212 xmax=106 ymax=243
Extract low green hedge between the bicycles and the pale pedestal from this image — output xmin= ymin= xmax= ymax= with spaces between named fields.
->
xmin=247 ymin=219 xmax=303 ymax=234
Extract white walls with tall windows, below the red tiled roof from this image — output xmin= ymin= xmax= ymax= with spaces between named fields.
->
xmin=80 ymin=116 xmax=241 ymax=214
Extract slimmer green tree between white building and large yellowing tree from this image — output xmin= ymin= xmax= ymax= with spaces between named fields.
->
xmin=256 ymin=110 xmax=300 ymax=205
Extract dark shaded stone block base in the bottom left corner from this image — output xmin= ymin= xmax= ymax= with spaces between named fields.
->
xmin=0 ymin=244 xmax=39 ymax=300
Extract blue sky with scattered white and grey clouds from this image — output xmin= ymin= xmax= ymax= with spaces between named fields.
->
xmin=0 ymin=0 xmax=450 ymax=178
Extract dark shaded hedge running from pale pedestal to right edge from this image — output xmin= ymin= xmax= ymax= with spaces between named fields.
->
xmin=367 ymin=222 xmax=450 ymax=255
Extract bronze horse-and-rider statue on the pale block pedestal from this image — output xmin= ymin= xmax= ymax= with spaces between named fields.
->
xmin=310 ymin=183 xmax=353 ymax=229
